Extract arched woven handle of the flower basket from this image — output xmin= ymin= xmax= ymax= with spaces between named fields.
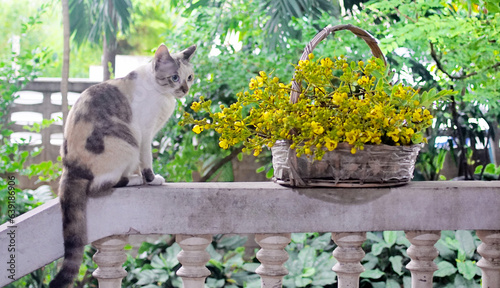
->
xmin=290 ymin=24 xmax=387 ymax=103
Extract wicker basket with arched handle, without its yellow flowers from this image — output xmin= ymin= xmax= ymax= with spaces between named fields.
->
xmin=271 ymin=25 xmax=422 ymax=187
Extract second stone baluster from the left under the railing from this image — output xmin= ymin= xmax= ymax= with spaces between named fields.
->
xmin=175 ymin=234 xmax=212 ymax=288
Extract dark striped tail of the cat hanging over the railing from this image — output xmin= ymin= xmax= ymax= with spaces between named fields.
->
xmin=50 ymin=171 xmax=90 ymax=288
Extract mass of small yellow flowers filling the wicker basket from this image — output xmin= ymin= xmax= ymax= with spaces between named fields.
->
xmin=181 ymin=54 xmax=448 ymax=159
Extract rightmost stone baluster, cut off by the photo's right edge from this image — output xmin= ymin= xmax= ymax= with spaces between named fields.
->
xmin=476 ymin=230 xmax=500 ymax=288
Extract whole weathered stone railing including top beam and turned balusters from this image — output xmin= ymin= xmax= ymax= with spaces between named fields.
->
xmin=0 ymin=181 xmax=500 ymax=288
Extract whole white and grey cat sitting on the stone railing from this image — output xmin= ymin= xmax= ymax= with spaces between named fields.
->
xmin=50 ymin=44 xmax=196 ymax=288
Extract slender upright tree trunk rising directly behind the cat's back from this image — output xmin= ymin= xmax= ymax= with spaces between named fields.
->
xmin=61 ymin=0 xmax=70 ymax=125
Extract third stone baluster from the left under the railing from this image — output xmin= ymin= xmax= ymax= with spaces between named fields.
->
xmin=255 ymin=233 xmax=292 ymax=288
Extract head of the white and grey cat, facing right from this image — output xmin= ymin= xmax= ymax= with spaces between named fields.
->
xmin=153 ymin=44 xmax=196 ymax=98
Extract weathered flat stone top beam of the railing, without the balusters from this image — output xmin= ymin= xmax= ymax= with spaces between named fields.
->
xmin=0 ymin=181 xmax=500 ymax=286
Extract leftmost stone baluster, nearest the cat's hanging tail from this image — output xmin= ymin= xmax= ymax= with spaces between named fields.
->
xmin=92 ymin=235 xmax=128 ymax=288
